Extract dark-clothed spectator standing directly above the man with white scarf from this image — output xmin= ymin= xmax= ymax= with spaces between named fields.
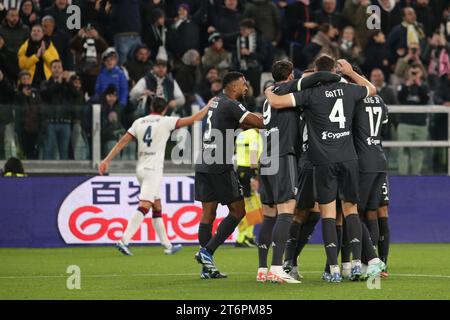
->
xmin=143 ymin=9 xmax=169 ymax=61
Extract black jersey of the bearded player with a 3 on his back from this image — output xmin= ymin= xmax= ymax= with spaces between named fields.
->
xmin=195 ymin=94 xmax=249 ymax=173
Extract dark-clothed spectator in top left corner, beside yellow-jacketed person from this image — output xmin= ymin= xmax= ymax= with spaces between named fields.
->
xmin=0 ymin=9 xmax=30 ymax=52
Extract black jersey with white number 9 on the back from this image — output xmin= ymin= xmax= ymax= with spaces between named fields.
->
xmin=261 ymin=80 xmax=300 ymax=163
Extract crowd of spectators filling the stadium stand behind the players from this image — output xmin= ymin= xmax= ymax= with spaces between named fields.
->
xmin=0 ymin=0 xmax=450 ymax=174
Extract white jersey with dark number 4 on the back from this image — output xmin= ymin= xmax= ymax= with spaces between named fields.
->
xmin=128 ymin=114 xmax=179 ymax=169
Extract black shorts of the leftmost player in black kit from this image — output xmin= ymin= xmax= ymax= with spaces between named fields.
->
xmin=195 ymin=170 xmax=243 ymax=205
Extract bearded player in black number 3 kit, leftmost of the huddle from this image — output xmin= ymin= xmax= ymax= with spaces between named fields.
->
xmin=195 ymin=72 xmax=263 ymax=279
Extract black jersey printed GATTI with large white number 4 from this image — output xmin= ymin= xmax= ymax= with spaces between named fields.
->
xmin=291 ymin=82 xmax=369 ymax=165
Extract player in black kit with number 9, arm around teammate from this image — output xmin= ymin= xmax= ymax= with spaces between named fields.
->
xmin=256 ymin=61 xmax=337 ymax=283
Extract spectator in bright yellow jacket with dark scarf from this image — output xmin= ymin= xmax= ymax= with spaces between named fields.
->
xmin=18 ymin=24 xmax=59 ymax=87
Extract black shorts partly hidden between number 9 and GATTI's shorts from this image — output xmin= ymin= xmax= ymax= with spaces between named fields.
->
xmin=295 ymin=160 xmax=316 ymax=210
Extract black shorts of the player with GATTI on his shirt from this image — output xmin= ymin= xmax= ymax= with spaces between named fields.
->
xmin=314 ymin=160 xmax=359 ymax=204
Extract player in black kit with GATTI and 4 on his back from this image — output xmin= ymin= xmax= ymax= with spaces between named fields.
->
xmin=265 ymin=55 xmax=376 ymax=282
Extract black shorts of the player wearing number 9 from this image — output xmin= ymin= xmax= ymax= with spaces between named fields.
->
xmin=259 ymin=154 xmax=297 ymax=205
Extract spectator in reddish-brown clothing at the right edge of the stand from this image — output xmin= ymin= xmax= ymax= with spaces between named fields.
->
xmin=423 ymin=32 xmax=450 ymax=89
